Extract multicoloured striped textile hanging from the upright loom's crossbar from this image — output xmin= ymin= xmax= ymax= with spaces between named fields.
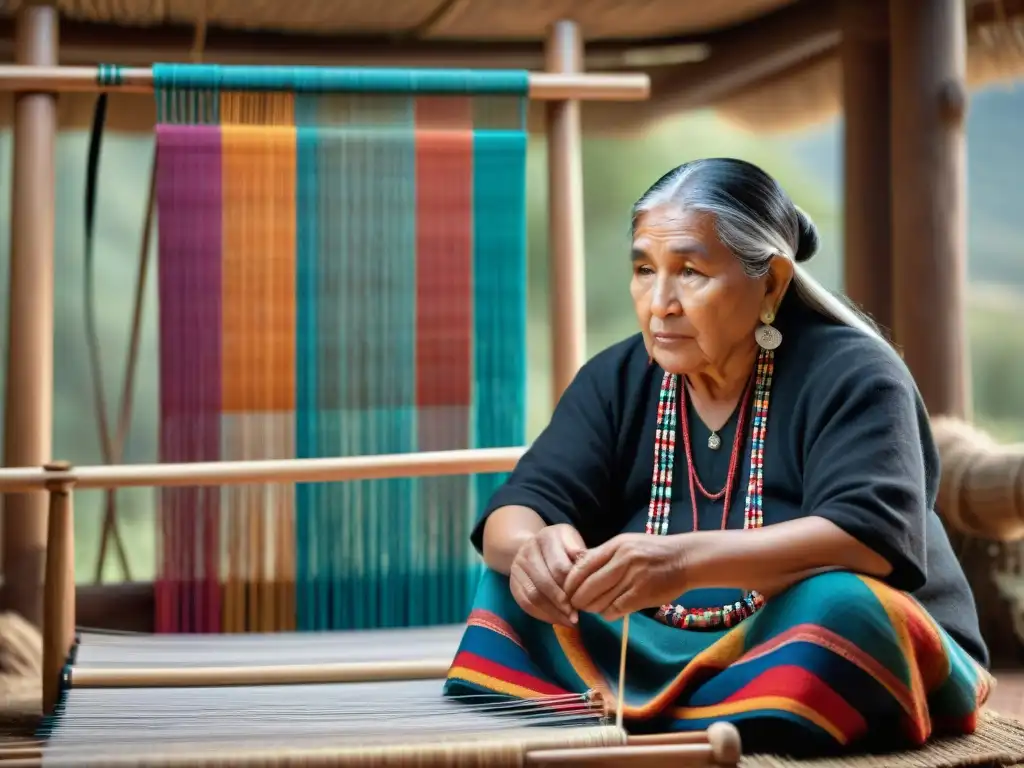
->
xmin=154 ymin=65 xmax=528 ymax=632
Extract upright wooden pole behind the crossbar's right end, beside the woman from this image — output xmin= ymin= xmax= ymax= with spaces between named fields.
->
xmin=547 ymin=22 xmax=587 ymax=402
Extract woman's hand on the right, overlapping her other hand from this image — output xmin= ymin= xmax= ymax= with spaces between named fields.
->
xmin=564 ymin=534 xmax=687 ymax=621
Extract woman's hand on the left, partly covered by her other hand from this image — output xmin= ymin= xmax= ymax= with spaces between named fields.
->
xmin=509 ymin=524 xmax=587 ymax=627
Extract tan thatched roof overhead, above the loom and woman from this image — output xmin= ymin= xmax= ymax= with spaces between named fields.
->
xmin=0 ymin=0 xmax=1024 ymax=131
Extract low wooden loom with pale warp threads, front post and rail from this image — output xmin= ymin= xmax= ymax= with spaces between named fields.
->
xmin=0 ymin=449 xmax=740 ymax=768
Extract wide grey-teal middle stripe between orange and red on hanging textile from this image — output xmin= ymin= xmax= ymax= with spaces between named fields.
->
xmin=296 ymin=96 xmax=419 ymax=630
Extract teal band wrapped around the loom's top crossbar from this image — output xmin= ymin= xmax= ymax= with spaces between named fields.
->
xmin=153 ymin=63 xmax=529 ymax=95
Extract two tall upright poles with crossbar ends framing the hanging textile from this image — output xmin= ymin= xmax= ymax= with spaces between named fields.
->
xmin=0 ymin=1 xmax=650 ymax=638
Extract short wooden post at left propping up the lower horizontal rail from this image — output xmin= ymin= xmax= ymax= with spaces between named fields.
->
xmin=43 ymin=462 xmax=75 ymax=715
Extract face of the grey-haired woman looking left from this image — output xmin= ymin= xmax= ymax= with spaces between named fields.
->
xmin=630 ymin=206 xmax=782 ymax=375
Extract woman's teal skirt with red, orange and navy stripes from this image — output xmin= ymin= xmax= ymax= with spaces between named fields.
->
xmin=444 ymin=570 xmax=992 ymax=752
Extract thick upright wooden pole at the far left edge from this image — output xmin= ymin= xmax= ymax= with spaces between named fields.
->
xmin=2 ymin=2 xmax=58 ymax=627
